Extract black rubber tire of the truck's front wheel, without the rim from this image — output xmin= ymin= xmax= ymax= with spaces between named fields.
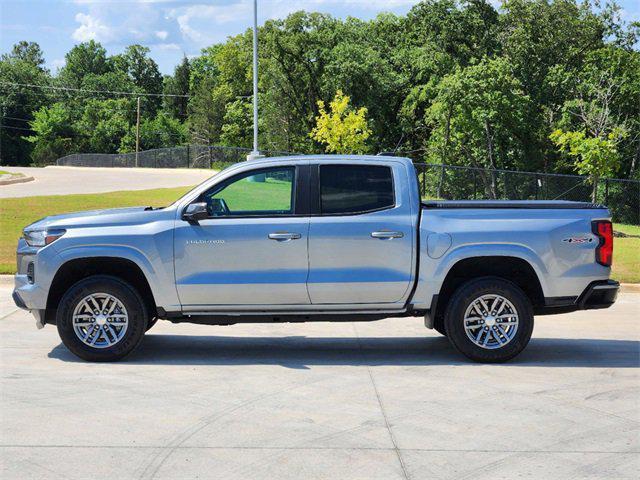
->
xmin=56 ymin=275 xmax=148 ymax=362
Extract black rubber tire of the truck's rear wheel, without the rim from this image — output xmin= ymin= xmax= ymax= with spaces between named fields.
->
xmin=444 ymin=277 xmax=533 ymax=363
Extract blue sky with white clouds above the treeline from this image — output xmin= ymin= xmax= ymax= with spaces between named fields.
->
xmin=0 ymin=0 xmax=640 ymax=74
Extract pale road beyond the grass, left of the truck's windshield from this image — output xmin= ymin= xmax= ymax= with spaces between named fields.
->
xmin=0 ymin=167 xmax=215 ymax=198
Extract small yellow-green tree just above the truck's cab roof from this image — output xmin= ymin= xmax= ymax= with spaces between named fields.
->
xmin=309 ymin=90 xmax=371 ymax=153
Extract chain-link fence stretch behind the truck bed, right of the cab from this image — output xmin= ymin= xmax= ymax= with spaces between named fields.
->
xmin=415 ymin=163 xmax=640 ymax=225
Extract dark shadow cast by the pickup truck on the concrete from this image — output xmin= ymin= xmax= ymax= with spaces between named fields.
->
xmin=49 ymin=334 xmax=640 ymax=369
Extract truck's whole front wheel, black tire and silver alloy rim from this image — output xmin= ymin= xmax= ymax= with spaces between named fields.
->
xmin=56 ymin=275 xmax=148 ymax=362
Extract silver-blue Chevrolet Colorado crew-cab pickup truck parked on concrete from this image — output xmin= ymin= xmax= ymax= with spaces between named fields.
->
xmin=13 ymin=156 xmax=619 ymax=362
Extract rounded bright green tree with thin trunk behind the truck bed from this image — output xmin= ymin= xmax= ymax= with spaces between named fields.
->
xmin=426 ymin=58 xmax=530 ymax=198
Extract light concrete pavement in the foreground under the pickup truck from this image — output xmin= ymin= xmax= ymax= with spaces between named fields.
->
xmin=0 ymin=286 xmax=640 ymax=480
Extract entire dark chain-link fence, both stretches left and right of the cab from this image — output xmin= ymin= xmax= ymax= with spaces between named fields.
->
xmin=56 ymin=145 xmax=640 ymax=225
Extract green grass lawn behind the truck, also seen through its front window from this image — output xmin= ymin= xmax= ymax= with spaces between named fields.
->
xmin=0 ymin=187 xmax=640 ymax=283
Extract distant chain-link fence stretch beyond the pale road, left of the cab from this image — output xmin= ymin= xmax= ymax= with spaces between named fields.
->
xmin=56 ymin=145 xmax=289 ymax=170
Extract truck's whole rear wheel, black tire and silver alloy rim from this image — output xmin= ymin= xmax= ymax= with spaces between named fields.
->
xmin=444 ymin=277 xmax=533 ymax=363
